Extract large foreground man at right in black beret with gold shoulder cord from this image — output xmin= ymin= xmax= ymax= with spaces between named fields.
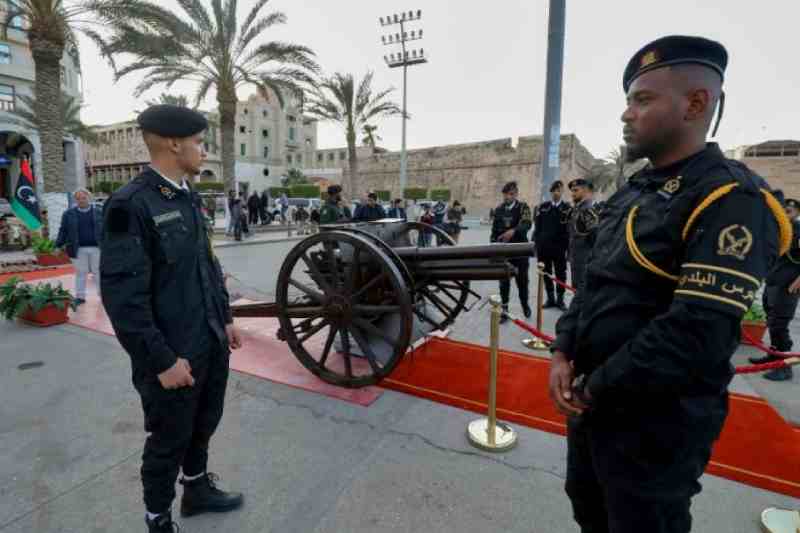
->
xmin=549 ymin=36 xmax=792 ymax=533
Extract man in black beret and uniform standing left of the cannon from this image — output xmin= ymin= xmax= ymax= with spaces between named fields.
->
xmin=100 ymin=105 xmax=243 ymax=532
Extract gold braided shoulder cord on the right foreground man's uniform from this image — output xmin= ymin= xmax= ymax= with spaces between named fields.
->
xmin=625 ymin=183 xmax=792 ymax=281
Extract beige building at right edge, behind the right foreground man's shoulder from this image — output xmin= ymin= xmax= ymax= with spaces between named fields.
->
xmin=726 ymin=140 xmax=800 ymax=199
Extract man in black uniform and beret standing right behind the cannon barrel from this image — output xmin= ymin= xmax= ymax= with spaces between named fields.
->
xmin=491 ymin=181 xmax=533 ymax=323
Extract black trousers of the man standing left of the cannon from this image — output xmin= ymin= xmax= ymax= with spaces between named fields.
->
xmin=134 ymin=349 xmax=230 ymax=513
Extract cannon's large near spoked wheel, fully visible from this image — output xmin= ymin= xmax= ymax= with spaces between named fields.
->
xmin=276 ymin=231 xmax=413 ymax=388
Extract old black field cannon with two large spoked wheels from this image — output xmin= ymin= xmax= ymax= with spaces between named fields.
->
xmin=233 ymin=220 xmax=533 ymax=388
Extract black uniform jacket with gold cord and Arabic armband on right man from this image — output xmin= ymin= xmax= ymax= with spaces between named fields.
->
xmin=553 ymin=144 xmax=791 ymax=428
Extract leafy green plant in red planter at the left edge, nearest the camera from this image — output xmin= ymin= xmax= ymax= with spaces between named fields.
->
xmin=0 ymin=276 xmax=77 ymax=326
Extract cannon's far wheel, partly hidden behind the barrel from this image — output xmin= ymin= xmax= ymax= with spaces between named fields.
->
xmin=396 ymin=222 xmax=470 ymax=330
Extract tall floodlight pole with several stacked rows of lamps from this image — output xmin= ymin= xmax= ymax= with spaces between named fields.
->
xmin=380 ymin=9 xmax=428 ymax=194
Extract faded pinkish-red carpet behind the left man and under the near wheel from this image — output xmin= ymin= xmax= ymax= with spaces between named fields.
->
xmin=28 ymin=276 xmax=383 ymax=406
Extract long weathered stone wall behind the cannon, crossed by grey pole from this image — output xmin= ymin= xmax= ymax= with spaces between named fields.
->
xmin=346 ymin=135 xmax=595 ymax=215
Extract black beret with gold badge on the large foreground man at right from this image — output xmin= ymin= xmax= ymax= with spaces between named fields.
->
xmin=622 ymin=35 xmax=728 ymax=93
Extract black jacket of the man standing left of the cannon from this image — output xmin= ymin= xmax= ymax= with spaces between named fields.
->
xmin=100 ymin=169 xmax=233 ymax=374
